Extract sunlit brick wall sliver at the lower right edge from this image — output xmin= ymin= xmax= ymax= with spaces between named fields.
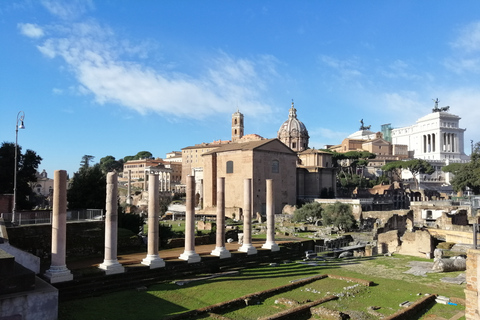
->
xmin=465 ymin=249 xmax=480 ymax=320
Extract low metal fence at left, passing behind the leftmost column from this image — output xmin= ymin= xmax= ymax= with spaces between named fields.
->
xmin=0 ymin=209 xmax=105 ymax=225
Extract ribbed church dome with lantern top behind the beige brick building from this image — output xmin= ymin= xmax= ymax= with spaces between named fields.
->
xmin=277 ymin=102 xmax=310 ymax=152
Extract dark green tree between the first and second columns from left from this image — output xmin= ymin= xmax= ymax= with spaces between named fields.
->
xmin=67 ymin=163 xmax=107 ymax=209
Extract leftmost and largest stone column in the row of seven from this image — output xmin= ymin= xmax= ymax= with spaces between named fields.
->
xmin=45 ymin=170 xmax=73 ymax=283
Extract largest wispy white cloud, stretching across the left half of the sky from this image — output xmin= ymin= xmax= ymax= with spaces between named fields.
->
xmin=34 ymin=22 xmax=275 ymax=118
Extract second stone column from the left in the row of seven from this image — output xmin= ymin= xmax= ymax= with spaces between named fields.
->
xmin=98 ymin=172 xmax=125 ymax=275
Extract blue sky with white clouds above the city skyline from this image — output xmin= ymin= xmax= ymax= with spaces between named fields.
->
xmin=0 ymin=0 xmax=480 ymax=177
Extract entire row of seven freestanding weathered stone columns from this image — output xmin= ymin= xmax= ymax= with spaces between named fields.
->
xmin=45 ymin=170 xmax=280 ymax=283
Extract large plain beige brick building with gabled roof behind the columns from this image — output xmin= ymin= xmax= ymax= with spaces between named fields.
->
xmin=202 ymin=139 xmax=297 ymax=217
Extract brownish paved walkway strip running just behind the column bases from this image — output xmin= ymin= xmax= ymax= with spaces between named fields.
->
xmin=67 ymin=239 xmax=298 ymax=270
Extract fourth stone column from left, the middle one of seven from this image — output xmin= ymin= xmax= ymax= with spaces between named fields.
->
xmin=178 ymin=176 xmax=201 ymax=263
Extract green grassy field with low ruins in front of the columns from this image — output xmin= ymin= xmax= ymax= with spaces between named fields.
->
xmin=59 ymin=255 xmax=465 ymax=320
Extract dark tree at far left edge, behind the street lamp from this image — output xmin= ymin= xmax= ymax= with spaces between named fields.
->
xmin=0 ymin=142 xmax=42 ymax=209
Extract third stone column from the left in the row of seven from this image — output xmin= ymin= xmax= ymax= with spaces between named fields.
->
xmin=142 ymin=173 xmax=165 ymax=269
